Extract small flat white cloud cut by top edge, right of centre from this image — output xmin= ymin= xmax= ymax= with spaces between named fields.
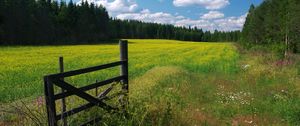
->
xmin=173 ymin=0 xmax=230 ymax=10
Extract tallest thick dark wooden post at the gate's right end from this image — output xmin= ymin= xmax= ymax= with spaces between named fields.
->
xmin=119 ymin=40 xmax=128 ymax=91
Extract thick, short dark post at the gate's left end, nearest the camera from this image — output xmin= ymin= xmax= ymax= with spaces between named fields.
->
xmin=44 ymin=76 xmax=57 ymax=126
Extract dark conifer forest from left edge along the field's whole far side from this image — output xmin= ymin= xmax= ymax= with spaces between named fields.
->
xmin=0 ymin=0 xmax=240 ymax=45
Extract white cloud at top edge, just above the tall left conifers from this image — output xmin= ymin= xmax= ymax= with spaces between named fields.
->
xmin=77 ymin=0 xmax=138 ymax=15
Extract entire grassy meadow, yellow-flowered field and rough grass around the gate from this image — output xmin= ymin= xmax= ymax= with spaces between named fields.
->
xmin=0 ymin=40 xmax=300 ymax=125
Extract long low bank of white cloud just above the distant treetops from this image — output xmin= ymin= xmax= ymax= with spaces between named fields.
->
xmin=116 ymin=9 xmax=246 ymax=31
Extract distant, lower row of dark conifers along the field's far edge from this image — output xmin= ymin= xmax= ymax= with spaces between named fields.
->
xmin=111 ymin=19 xmax=240 ymax=42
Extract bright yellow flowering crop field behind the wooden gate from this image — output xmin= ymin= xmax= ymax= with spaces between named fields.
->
xmin=0 ymin=40 xmax=238 ymax=102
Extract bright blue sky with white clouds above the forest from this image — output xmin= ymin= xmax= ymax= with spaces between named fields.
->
xmin=71 ymin=0 xmax=263 ymax=31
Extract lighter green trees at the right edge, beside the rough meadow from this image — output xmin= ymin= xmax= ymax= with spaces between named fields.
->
xmin=240 ymin=0 xmax=300 ymax=53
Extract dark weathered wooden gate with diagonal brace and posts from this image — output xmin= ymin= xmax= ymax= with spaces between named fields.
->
xmin=44 ymin=40 xmax=128 ymax=126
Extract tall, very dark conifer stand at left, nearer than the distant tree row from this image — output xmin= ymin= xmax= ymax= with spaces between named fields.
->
xmin=0 ymin=0 xmax=109 ymax=45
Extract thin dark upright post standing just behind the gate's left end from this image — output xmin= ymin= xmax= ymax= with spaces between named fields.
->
xmin=59 ymin=57 xmax=68 ymax=126
